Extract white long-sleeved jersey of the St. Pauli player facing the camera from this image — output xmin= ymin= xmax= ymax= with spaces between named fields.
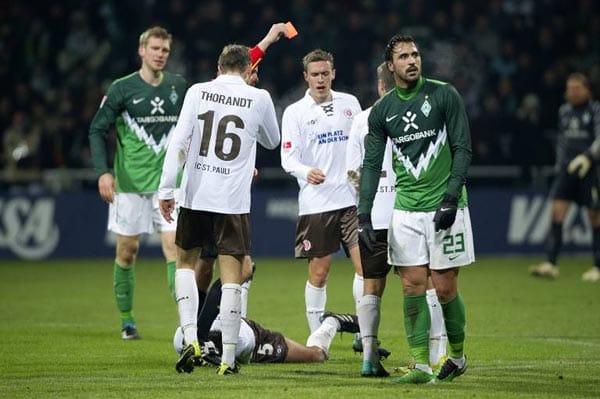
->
xmin=281 ymin=90 xmax=361 ymax=215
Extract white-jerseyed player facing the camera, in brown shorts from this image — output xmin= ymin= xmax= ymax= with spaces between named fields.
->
xmin=281 ymin=50 xmax=363 ymax=333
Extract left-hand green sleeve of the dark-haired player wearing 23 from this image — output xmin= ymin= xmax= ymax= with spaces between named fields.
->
xmin=358 ymin=105 xmax=387 ymax=215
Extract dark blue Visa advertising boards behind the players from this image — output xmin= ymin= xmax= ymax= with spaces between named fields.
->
xmin=0 ymin=188 xmax=592 ymax=260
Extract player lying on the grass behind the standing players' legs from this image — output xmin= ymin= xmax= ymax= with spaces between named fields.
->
xmin=173 ymin=312 xmax=364 ymax=366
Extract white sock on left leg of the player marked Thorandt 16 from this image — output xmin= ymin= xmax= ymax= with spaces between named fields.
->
xmin=175 ymin=269 xmax=198 ymax=345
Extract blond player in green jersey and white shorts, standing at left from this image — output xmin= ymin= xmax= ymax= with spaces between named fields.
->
xmin=89 ymin=27 xmax=187 ymax=340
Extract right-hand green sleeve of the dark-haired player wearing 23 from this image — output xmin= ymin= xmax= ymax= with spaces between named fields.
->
xmin=445 ymin=85 xmax=471 ymax=198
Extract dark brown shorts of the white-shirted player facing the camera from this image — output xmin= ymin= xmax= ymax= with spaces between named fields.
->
xmin=295 ymin=206 xmax=358 ymax=258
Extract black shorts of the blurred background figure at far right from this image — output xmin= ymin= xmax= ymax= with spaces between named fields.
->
xmin=550 ymin=166 xmax=600 ymax=209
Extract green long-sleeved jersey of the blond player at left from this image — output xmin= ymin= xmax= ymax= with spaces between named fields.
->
xmin=89 ymin=72 xmax=186 ymax=193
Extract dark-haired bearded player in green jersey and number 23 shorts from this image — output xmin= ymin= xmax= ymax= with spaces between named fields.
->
xmin=358 ymin=35 xmax=475 ymax=383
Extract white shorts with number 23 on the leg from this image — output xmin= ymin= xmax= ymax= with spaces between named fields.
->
xmin=388 ymin=208 xmax=475 ymax=270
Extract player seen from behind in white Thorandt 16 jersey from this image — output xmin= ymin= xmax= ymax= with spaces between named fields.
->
xmin=159 ymin=45 xmax=280 ymax=375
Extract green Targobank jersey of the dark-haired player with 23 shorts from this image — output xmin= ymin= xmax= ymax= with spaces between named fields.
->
xmin=359 ymin=78 xmax=471 ymax=213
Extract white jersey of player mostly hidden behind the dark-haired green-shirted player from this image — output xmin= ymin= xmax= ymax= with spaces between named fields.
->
xmin=346 ymin=108 xmax=396 ymax=230
